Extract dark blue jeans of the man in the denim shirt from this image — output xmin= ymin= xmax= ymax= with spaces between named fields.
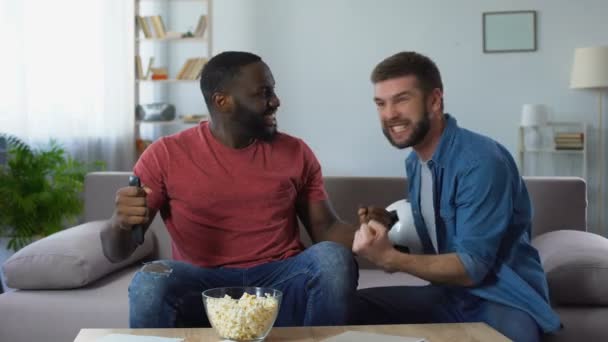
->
xmin=351 ymin=285 xmax=541 ymax=342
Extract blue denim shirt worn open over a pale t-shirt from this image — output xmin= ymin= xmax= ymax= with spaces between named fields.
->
xmin=405 ymin=114 xmax=560 ymax=332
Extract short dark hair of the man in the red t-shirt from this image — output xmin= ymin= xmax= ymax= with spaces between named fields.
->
xmin=200 ymin=51 xmax=262 ymax=110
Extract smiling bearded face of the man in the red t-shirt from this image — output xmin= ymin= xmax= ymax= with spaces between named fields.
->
xmin=231 ymin=62 xmax=281 ymax=141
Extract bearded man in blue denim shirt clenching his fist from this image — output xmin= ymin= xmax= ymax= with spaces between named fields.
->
xmin=353 ymin=52 xmax=560 ymax=341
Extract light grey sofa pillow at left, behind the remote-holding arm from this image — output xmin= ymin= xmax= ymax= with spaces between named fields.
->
xmin=3 ymin=221 xmax=154 ymax=290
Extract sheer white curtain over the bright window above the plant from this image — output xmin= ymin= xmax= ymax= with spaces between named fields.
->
xmin=0 ymin=0 xmax=134 ymax=170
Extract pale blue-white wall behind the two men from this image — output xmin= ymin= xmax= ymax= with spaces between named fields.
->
xmin=214 ymin=0 xmax=608 ymax=224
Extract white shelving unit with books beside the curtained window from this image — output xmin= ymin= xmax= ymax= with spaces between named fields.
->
xmin=133 ymin=0 xmax=213 ymax=156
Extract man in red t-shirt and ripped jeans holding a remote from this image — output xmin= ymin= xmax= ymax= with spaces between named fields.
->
xmin=101 ymin=52 xmax=358 ymax=328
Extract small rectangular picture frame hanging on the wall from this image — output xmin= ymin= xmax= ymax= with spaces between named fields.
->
xmin=482 ymin=11 xmax=537 ymax=53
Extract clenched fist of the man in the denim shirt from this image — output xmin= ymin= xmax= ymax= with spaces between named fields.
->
xmin=353 ymin=220 xmax=396 ymax=272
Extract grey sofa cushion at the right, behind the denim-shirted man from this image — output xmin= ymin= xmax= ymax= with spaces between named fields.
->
xmin=532 ymin=230 xmax=608 ymax=305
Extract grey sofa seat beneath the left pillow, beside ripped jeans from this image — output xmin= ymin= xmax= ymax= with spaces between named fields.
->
xmin=0 ymin=263 xmax=138 ymax=342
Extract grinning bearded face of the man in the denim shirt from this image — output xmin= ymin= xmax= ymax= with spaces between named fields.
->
xmin=374 ymin=75 xmax=431 ymax=149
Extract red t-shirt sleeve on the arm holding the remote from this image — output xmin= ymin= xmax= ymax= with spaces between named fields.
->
xmin=133 ymin=139 xmax=169 ymax=210
